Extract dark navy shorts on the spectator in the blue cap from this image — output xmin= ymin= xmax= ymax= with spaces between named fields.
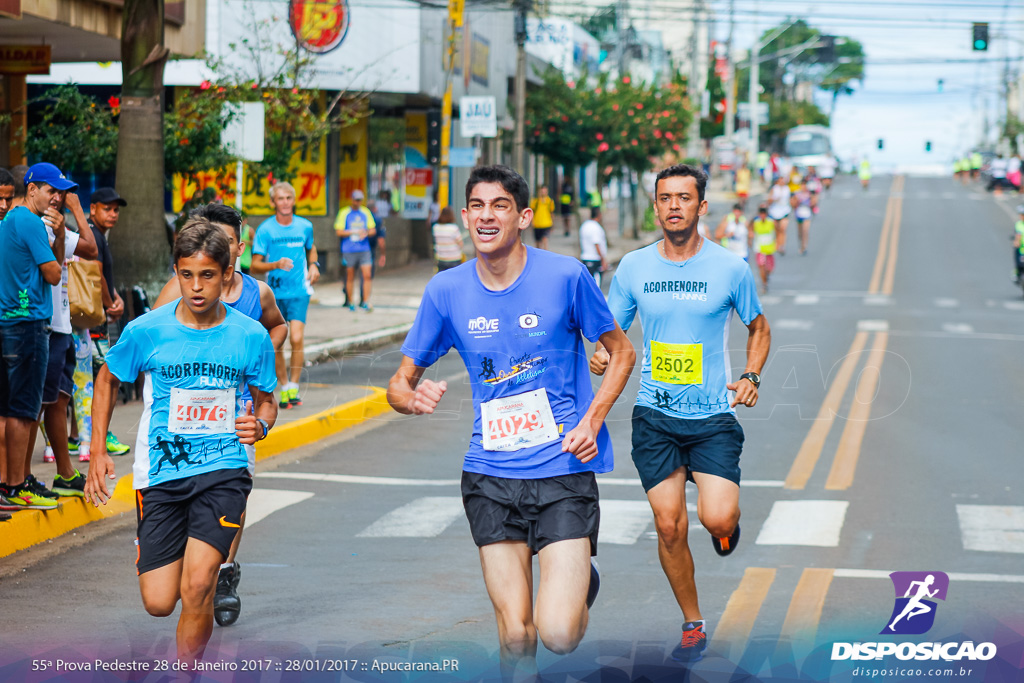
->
xmin=0 ymin=321 xmax=50 ymax=421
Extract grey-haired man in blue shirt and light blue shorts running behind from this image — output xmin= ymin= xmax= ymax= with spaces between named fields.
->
xmin=251 ymin=182 xmax=319 ymax=410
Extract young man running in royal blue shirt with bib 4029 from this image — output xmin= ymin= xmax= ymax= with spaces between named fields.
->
xmin=388 ymin=166 xmax=636 ymax=673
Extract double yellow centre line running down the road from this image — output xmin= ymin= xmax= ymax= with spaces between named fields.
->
xmin=715 ymin=176 xmax=904 ymax=661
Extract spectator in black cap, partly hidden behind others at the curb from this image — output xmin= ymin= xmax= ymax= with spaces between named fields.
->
xmin=79 ymin=187 xmax=131 ymax=462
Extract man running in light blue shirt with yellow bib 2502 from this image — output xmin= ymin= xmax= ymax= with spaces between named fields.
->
xmin=591 ymin=164 xmax=771 ymax=661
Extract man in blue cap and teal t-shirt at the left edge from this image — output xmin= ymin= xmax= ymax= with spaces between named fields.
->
xmin=0 ymin=164 xmax=78 ymax=510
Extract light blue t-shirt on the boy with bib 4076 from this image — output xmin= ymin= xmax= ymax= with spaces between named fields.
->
xmin=106 ymin=299 xmax=278 ymax=488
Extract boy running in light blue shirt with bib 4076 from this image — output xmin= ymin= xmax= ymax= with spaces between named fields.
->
xmin=85 ymin=219 xmax=278 ymax=669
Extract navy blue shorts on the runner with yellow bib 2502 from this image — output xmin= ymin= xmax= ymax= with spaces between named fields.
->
xmin=633 ymin=405 xmax=743 ymax=490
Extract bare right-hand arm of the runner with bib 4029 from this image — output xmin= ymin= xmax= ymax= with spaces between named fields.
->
xmin=562 ymin=323 xmax=637 ymax=463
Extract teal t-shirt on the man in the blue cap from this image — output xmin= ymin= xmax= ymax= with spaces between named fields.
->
xmin=0 ymin=206 xmax=56 ymax=325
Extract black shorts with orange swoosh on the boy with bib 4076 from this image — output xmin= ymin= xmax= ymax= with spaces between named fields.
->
xmin=135 ymin=467 xmax=253 ymax=574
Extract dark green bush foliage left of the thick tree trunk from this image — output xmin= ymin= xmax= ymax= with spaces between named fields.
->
xmin=26 ymin=83 xmax=118 ymax=173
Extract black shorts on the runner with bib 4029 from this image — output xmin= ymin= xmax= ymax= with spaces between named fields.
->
xmin=462 ymin=472 xmax=601 ymax=555
